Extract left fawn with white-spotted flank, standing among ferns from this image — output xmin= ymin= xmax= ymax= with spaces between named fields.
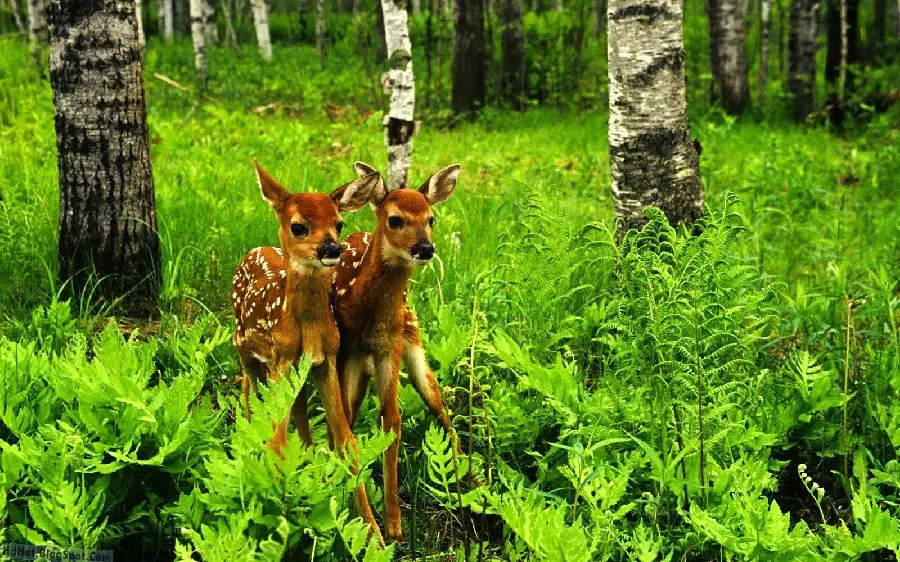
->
xmin=232 ymin=160 xmax=384 ymax=542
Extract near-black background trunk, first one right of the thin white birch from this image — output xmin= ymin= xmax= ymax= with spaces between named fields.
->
xmin=451 ymin=0 xmax=485 ymax=114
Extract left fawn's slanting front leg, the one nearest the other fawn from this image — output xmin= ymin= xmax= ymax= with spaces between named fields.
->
xmin=313 ymin=358 xmax=384 ymax=544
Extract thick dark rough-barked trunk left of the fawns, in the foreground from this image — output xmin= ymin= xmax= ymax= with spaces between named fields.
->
xmin=48 ymin=0 xmax=160 ymax=314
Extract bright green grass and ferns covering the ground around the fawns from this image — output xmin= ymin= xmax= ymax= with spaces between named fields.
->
xmin=0 ymin=30 xmax=900 ymax=561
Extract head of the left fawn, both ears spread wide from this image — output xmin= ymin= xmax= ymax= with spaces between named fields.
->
xmin=253 ymin=160 xmax=384 ymax=270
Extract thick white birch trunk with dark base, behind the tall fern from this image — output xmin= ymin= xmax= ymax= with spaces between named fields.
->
xmin=607 ymin=0 xmax=703 ymax=229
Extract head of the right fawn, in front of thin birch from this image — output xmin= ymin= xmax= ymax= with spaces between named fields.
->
xmin=353 ymin=162 xmax=459 ymax=264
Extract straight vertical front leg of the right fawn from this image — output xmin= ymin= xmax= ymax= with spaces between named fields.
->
xmin=375 ymin=341 xmax=403 ymax=541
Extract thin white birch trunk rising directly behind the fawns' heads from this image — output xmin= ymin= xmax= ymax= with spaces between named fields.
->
xmin=381 ymin=0 xmax=416 ymax=191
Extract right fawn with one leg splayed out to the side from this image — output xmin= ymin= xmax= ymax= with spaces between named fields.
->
xmin=333 ymin=162 xmax=472 ymax=540
